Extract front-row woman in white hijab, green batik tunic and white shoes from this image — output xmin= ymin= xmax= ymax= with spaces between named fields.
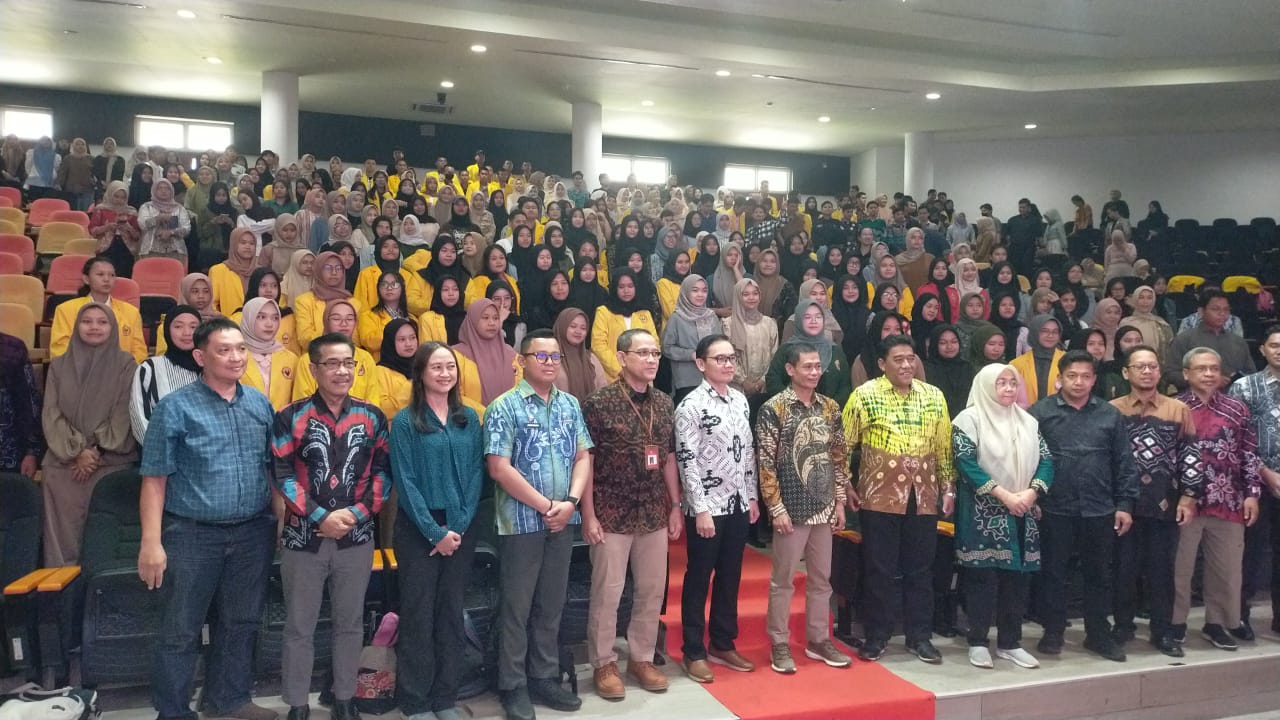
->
xmin=951 ymin=364 xmax=1053 ymax=667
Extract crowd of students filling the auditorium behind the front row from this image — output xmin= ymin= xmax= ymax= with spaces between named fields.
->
xmin=0 ymin=138 xmax=1280 ymax=717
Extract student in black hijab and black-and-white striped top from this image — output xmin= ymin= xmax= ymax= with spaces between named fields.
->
xmin=129 ymin=305 xmax=200 ymax=445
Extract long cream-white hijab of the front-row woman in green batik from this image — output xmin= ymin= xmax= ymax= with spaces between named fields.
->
xmin=951 ymin=363 xmax=1039 ymax=492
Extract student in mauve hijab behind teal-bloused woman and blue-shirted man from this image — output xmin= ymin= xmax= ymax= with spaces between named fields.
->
xmin=453 ymin=297 xmax=522 ymax=407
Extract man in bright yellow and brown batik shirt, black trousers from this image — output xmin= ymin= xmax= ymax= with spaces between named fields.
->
xmin=844 ymin=334 xmax=956 ymax=665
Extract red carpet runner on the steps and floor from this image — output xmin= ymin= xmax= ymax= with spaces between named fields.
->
xmin=663 ymin=538 xmax=933 ymax=720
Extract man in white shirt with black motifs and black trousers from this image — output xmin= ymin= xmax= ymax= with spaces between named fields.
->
xmin=676 ymin=334 xmax=760 ymax=683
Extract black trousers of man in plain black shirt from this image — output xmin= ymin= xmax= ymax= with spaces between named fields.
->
xmin=1036 ymin=512 xmax=1116 ymax=639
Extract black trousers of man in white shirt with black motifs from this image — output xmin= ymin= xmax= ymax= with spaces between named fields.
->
xmin=680 ymin=507 xmax=750 ymax=661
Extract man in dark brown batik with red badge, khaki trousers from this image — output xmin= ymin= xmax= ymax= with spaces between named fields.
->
xmin=582 ymin=328 xmax=684 ymax=700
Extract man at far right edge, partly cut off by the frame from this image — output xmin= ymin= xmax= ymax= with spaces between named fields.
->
xmin=1230 ymin=325 xmax=1280 ymax=632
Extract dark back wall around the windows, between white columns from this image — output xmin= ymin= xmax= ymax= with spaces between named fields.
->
xmin=0 ymin=85 xmax=849 ymax=193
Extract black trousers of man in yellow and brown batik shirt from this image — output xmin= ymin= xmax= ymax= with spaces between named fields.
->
xmin=859 ymin=495 xmax=938 ymax=646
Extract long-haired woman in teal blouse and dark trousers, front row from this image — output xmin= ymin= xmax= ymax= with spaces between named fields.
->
xmin=390 ymin=342 xmax=484 ymax=717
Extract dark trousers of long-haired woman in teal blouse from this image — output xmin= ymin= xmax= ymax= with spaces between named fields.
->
xmin=394 ymin=511 xmax=479 ymax=715
